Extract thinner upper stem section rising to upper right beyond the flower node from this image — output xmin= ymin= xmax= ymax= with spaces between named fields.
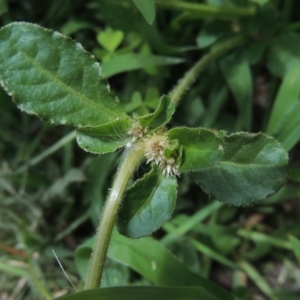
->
xmin=169 ymin=35 xmax=247 ymax=105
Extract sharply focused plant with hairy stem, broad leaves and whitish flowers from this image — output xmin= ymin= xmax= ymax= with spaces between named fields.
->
xmin=0 ymin=23 xmax=288 ymax=300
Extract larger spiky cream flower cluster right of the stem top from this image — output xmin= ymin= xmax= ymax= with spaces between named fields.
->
xmin=144 ymin=133 xmax=179 ymax=176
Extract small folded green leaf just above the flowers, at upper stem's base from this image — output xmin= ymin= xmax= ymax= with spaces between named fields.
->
xmin=137 ymin=96 xmax=175 ymax=130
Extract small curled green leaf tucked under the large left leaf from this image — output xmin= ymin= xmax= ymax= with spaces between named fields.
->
xmin=77 ymin=118 xmax=131 ymax=154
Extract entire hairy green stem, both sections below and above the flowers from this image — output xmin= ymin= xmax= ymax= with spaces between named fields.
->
xmin=85 ymin=32 xmax=245 ymax=289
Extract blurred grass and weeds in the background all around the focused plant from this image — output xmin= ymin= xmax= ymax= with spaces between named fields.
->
xmin=0 ymin=0 xmax=300 ymax=300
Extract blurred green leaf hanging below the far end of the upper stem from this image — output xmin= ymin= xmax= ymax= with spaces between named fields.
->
xmin=221 ymin=53 xmax=253 ymax=130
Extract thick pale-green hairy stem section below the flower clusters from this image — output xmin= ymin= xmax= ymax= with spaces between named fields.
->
xmin=85 ymin=144 xmax=144 ymax=289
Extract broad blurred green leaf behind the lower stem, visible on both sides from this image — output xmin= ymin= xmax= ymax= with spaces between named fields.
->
xmin=75 ymin=231 xmax=233 ymax=300
